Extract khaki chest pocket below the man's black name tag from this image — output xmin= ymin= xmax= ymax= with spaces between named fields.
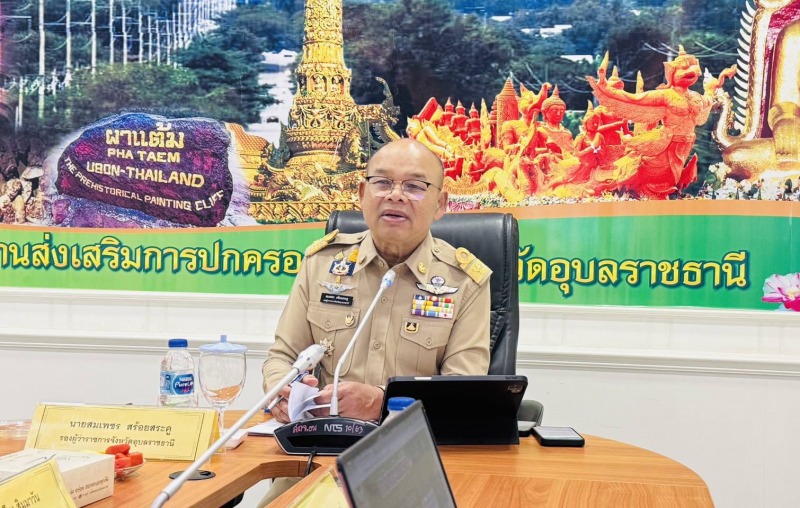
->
xmin=306 ymin=303 xmax=361 ymax=376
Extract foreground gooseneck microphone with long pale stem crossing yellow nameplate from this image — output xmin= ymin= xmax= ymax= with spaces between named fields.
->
xmin=150 ymin=344 xmax=325 ymax=508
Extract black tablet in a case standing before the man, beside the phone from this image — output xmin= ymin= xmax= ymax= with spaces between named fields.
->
xmin=382 ymin=375 xmax=528 ymax=445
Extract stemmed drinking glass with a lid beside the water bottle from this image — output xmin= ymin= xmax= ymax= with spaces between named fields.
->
xmin=197 ymin=335 xmax=247 ymax=435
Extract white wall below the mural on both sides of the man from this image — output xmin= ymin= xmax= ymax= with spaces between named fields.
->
xmin=0 ymin=288 xmax=800 ymax=508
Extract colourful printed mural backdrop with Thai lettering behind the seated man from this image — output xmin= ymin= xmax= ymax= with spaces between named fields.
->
xmin=0 ymin=0 xmax=800 ymax=311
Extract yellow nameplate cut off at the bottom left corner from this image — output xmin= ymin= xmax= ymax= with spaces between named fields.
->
xmin=0 ymin=459 xmax=75 ymax=508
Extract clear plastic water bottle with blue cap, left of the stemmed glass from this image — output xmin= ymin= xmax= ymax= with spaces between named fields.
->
xmin=158 ymin=339 xmax=197 ymax=407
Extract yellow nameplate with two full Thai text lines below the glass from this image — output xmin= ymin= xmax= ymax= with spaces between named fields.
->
xmin=25 ymin=403 xmax=219 ymax=461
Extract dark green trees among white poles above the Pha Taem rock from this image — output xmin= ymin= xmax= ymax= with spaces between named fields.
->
xmin=9 ymin=0 xmax=292 ymax=143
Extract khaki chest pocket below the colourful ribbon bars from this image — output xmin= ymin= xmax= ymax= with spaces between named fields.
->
xmin=396 ymin=318 xmax=453 ymax=376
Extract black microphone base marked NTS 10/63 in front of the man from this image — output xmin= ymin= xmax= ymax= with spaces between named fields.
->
xmin=275 ymin=416 xmax=378 ymax=455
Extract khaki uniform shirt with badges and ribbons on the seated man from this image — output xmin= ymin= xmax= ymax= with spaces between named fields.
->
xmin=263 ymin=232 xmax=491 ymax=391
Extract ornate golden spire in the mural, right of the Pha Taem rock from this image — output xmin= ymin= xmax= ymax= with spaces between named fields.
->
xmin=248 ymin=0 xmax=400 ymax=223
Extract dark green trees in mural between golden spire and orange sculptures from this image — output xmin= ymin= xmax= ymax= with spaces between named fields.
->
xmin=344 ymin=0 xmax=523 ymax=129
